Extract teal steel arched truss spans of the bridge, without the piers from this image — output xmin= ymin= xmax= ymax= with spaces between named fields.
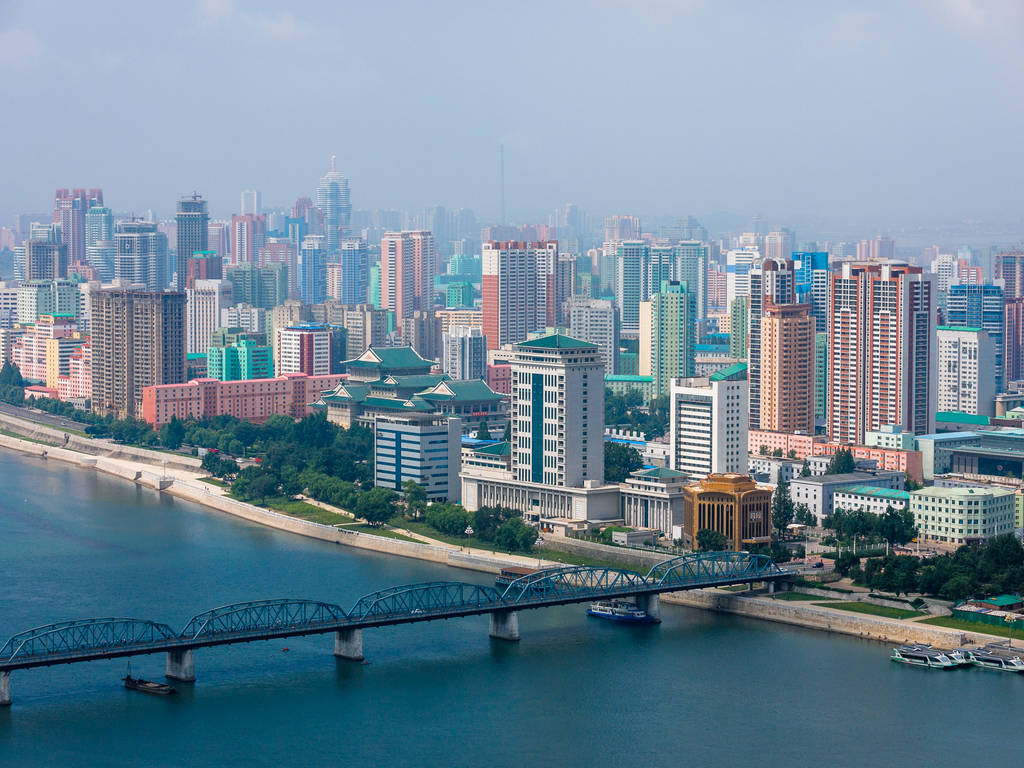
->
xmin=0 ymin=552 xmax=786 ymax=672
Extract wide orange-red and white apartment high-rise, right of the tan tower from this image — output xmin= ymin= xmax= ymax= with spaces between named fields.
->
xmin=828 ymin=262 xmax=937 ymax=444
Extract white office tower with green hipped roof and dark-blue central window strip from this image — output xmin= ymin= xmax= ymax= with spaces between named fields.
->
xmin=510 ymin=335 xmax=604 ymax=487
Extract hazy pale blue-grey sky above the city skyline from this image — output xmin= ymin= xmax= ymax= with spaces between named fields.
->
xmin=0 ymin=0 xmax=1024 ymax=230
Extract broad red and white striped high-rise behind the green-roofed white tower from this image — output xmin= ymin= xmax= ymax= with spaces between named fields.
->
xmin=481 ymin=241 xmax=558 ymax=349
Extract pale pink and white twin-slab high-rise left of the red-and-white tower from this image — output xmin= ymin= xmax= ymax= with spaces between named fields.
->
xmin=381 ymin=230 xmax=436 ymax=319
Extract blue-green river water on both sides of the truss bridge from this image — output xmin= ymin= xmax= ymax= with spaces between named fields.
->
xmin=0 ymin=453 xmax=1024 ymax=768
